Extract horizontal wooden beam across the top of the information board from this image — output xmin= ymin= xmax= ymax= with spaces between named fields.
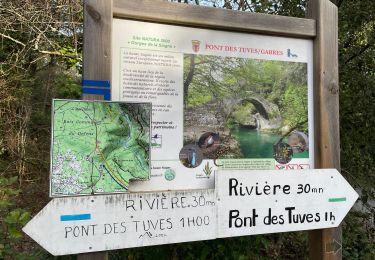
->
xmin=113 ymin=0 xmax=316 ymax=38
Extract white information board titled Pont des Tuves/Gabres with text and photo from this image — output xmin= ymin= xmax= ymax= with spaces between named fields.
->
xmin=111 ymin=19 xmax=314 ymax=191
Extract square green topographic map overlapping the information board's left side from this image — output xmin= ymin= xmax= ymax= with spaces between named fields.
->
xmin=50 ymin=99 xmax=151 ymax=197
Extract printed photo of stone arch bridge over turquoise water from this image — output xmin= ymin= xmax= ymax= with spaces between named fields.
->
xmin=184 ymin=54 xmax=309 ymax=158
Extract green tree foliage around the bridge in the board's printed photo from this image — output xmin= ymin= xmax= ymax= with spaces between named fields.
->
xmin=184 ymin=55 xmax=307 ymax=131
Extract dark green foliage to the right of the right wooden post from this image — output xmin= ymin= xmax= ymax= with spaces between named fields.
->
xmin=339 ymin=0 xmax=375 ymax=259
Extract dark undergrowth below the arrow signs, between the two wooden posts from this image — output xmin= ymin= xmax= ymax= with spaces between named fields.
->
xmin=110 ymin=232 xmax=307 ymax=260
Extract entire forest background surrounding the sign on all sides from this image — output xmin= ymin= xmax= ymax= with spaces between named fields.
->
xmin=0 ymin=0 xmax=375 ymax=259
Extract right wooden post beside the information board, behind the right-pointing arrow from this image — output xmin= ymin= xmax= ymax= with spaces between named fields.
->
xmin=307 ymin=0 xmax=342 ymax=260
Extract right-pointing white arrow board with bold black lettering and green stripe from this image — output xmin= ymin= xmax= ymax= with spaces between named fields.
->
xmin=216 ymin=169 xmax=358 ymax=237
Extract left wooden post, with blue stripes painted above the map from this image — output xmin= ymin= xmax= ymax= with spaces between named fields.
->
xmin=77 ymin=0 xmax=113 ymax=260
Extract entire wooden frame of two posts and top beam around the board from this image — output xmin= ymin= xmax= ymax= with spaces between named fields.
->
xmin=82 ymin=0 xmax=342 ymax=260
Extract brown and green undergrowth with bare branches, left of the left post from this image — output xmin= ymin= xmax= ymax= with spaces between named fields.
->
xmin=0 ymin=0 xmax=83 ymax=259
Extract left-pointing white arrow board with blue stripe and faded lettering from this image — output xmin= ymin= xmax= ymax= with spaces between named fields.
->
xmin=23 ymin=190 xmax=216 ymax=255
